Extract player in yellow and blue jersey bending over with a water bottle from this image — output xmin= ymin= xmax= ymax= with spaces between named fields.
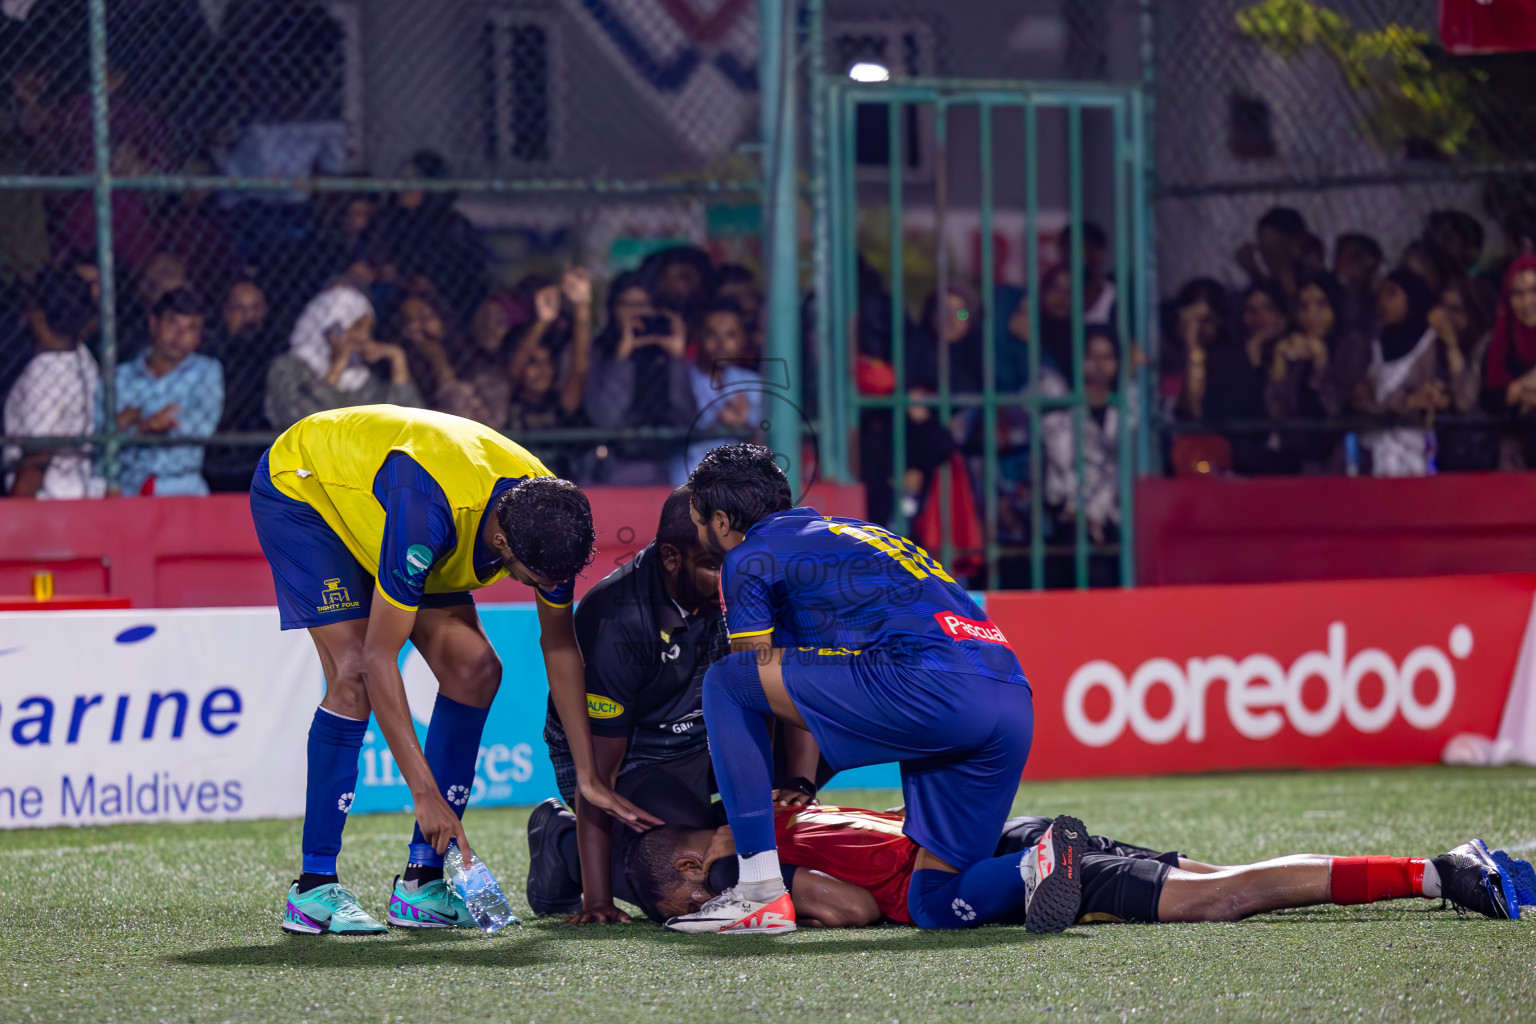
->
xmin=250 ymin=405 xmax=659 ymax=935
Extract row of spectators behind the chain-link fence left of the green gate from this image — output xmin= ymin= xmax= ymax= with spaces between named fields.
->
xmin=0 ymin=224 xmax=762 ymax=497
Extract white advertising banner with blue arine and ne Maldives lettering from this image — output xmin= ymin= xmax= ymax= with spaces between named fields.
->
xmin=0 ymin=608 xmax=319 ymax=829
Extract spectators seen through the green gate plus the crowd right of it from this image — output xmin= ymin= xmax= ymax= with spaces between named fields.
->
xmin=854 ymin=207 xmax=1536 ymax=585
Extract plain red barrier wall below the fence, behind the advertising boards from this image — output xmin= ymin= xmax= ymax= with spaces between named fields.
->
xmin=12 ymin=473 xmax=1536 ymax=608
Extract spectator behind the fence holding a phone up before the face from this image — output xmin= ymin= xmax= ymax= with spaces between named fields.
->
xmin=585 ymin=273 xmax=697 ymax=485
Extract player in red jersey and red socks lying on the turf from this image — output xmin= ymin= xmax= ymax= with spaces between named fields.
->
xmin=625 ymin=806 xmax=1536 ymax=927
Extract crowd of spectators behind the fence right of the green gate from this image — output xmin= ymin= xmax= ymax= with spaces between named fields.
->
xmin=1158 ymin=207 xmax=1536 ymax=476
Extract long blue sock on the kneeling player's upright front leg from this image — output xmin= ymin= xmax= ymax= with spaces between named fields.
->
xmin=703 ymin=651 xmax=779 ymax=859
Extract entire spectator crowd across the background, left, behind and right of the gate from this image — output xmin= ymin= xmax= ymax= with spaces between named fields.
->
xmin=9 ymin=0 xmax=1536 ymax=583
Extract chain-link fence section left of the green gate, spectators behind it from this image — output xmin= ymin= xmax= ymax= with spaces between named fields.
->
xmin=0 ymin=0 xmax=760 ymax=496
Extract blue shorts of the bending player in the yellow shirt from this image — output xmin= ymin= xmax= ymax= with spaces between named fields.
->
xmin=250 ymin=453 xmax=475 ymax=629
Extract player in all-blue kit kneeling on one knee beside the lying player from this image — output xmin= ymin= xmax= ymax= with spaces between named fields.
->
xmin=667 ymin=445 xmax=1086 ymax=935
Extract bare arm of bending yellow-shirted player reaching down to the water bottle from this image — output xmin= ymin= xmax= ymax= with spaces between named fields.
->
xmin=362 ymin=588 xmax=472 ymax=864
